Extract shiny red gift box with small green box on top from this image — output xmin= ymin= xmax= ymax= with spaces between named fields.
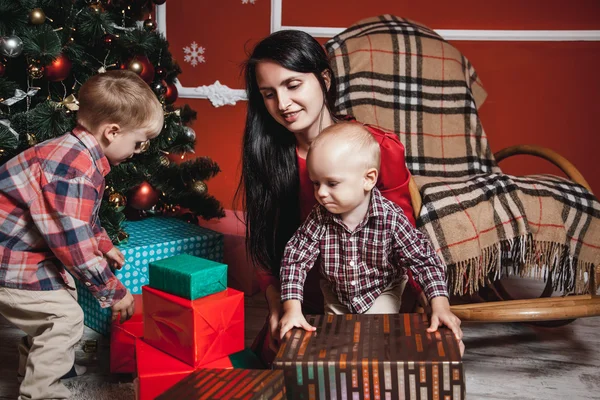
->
xmin=143 ymin=286 xmax=244 ymax=367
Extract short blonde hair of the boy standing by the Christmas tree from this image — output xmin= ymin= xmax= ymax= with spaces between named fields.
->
xmin=77 ymin=70 xmax=164 ymax=134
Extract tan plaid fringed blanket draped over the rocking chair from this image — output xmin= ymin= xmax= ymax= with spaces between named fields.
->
xmin=325 ymin=15 xmax=600 ymax=295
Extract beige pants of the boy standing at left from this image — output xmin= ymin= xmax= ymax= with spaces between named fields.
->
xmin=0 ymin=275 xmax=83 ymax=400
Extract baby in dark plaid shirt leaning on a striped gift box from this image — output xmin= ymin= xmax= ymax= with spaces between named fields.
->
xmin=280 ymin=123 xmax=462 ymax=346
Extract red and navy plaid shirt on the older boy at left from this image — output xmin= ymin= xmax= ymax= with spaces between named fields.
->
xmin=0 ymin=128 xmax=126 ymax=307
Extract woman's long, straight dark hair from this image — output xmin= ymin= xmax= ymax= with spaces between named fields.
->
xmin=234 ymin=30 xmax=335 ymax=277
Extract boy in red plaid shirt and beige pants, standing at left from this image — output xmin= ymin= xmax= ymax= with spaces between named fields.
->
xmin=0 ymin=71 xmax=163 ymax=399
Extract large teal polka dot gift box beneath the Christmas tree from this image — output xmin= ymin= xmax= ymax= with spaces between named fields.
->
xmin=77 ymin=217 xmax=223 ymax=335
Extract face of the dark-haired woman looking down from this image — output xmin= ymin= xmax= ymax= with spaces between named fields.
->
xmin=256 ymin=61 xmax=328 ymax=137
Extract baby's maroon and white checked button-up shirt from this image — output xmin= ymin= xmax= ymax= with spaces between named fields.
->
xmin=281 ymin=188 xmax=448 ymax=313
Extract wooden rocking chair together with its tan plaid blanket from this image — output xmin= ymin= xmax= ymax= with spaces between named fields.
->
xmin=325 ymin=15 xmax=600 ymax=322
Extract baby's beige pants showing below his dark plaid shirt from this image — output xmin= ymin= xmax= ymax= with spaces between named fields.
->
xmin=321 ymin=276 xmax=408 ymax=315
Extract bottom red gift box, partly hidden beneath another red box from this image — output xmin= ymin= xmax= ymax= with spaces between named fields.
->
xmin=135 ymin=338 xmax=194 ymax=400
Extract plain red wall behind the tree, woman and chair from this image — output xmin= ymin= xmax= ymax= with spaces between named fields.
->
xmin=166 ymin=0 xmax=600 ymax=208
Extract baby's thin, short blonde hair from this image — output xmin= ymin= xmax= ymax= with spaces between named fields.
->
xmin=306 ymin=122 xmax=381 ymax=172
